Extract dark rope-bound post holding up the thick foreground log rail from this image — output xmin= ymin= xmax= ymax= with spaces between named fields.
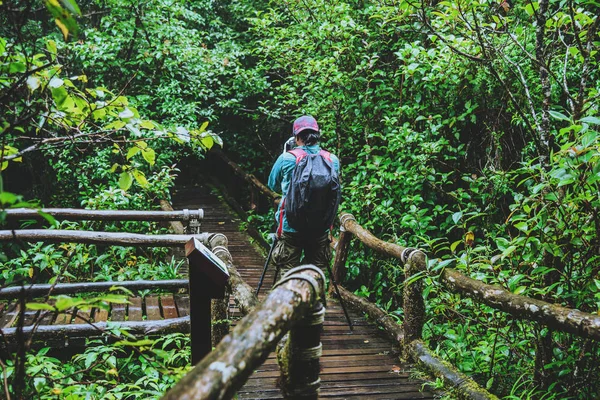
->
xmin=277 ymin=265 xmax=325 ymax=399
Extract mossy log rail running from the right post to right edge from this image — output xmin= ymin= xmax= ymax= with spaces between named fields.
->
xmin=440 ymin=268 xmax=600 ymax=340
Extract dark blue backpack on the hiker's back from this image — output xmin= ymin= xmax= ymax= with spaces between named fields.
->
xmin=283 ymin=149 xmax=341 ymax=234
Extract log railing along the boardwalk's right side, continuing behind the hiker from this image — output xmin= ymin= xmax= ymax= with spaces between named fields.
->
xmin=212 ymin=153 xmax=600 ymax=399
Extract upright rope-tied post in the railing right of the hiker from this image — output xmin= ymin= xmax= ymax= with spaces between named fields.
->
xmin=401 ymin=248 xmax=426 ymax=360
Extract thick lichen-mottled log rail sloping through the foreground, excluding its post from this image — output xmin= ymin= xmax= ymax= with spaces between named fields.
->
xmin=163 ymin=266 xmax=324 ymax=400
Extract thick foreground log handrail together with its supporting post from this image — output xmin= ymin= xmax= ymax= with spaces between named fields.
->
xmin=163 ymin=266 xmax=325 ymax=400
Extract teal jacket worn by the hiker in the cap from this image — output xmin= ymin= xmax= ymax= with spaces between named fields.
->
xmin=268 ymin=144 xmax=340 ymax=232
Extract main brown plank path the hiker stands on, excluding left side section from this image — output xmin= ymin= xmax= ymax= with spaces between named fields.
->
xmin=173 ymin=187 xmax=434 ymax=399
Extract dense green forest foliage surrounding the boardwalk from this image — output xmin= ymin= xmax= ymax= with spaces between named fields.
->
xmin=0 ymin=0 xmax=600 ymax=399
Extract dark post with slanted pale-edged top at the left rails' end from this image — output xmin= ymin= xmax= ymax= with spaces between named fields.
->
xmin=185 ymin=238 xmax=229 ymax=365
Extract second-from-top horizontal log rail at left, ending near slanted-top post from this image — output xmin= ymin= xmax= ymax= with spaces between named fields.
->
xmin=0 ymin=229 xmax=208 ymax=247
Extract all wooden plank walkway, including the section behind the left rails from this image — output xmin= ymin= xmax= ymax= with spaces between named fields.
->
xmin=0 ymin=183 xmax=434 ymax=399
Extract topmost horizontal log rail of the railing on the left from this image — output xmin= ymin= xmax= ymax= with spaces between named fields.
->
xmin=4 ymin=208 xmax=204 ymax=221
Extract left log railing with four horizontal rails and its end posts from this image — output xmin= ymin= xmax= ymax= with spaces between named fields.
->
xmin=0 ymin=206 xmax=246 ymax=361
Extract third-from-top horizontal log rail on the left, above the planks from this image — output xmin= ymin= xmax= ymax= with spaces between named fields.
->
xmin=0 ymin=279 xmax=188 ymax=300
